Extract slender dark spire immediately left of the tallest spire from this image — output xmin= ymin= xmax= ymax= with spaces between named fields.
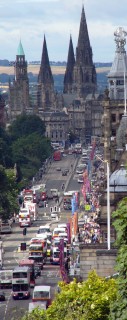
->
xmin=64 ymin=36 xmax=75 ymax=93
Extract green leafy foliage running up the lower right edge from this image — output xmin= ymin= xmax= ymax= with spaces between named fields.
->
xmin=110 ymin=198 xmax=127 ymax=320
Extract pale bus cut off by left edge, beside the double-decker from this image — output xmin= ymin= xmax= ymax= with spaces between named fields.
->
xmin=0 ymin=270 xmax=13 ymax=289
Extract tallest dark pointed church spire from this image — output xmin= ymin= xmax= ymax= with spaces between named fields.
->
xmin=73 ymin=6 xmax=97 ymax=98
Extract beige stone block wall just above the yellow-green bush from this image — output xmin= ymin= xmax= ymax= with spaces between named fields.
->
xmin=80 ymin=244 xmax=117 ymax=280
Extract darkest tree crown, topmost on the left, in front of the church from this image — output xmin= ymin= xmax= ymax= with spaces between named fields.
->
xmin=9 ymin=114 xmax=45 ymax=140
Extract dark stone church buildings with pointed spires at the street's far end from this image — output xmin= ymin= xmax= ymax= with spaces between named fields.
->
xmin=9 ymin=6 xmax=102 ymax=143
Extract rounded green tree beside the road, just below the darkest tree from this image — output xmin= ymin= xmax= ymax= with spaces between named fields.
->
xmin=12 ymin=132 xmax=51 ymax=179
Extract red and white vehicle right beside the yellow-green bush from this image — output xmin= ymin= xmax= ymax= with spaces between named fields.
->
xmin=32 ymin=286 xmax=51 ymax=309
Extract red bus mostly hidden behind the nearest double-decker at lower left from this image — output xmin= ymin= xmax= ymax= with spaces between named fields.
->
xmin=19 ymin=259 xmax=35 ymax=287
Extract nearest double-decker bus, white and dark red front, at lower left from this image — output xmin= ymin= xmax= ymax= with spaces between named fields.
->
xmin=12 ymin=266 xmax=30 ymax=299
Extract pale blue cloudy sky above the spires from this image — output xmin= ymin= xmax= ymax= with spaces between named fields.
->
xmin=0 ymin=0 xmax=127 ymax=62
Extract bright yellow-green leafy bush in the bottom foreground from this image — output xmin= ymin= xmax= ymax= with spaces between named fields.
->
xmin=22 ymin=271 xmax=117 ymax=320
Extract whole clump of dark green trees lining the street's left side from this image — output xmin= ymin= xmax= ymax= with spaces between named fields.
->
xmin=0 ymin=114 xmax=52 ymax=218
